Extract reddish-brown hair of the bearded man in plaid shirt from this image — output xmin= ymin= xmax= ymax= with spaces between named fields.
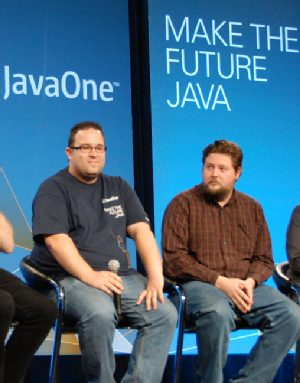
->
xmin=202 ymin=140 xmax=243 ymax=171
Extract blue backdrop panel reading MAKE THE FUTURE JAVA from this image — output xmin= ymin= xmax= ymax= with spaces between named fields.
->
xmin=148 ymin=0 xmax=300 ymax=354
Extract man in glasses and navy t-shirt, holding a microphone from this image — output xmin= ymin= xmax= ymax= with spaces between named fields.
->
xmin=31 ymin=122 xmax=177 ymax=383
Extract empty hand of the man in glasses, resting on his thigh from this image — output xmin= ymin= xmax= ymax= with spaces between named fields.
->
xmin=136 ymin=274 xmax=165 ymax=310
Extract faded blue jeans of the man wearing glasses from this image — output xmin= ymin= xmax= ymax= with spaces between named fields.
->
xmin=61 ymin=274 xmax=177 ymax=383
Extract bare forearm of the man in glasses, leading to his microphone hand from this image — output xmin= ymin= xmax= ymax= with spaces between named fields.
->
xmin=44 ymin=234 xmax=93 ymax=283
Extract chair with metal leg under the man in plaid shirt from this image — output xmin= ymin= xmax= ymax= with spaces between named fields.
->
xmin=169 ymin=281 xmax=272 ymax=383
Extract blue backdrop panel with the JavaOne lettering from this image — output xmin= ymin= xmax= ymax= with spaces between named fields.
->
xmin=0 ymin=0 xmax=136 ymax=275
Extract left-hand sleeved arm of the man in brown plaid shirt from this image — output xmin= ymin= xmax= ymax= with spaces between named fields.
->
xmin=162 ymin=196 xmax=219 ymax=284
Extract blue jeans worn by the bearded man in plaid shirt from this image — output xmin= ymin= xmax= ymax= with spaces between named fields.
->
xmin=183 ymin=281 xmax=300 ymax=383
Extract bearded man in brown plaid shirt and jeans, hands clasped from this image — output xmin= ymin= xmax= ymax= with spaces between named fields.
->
xmin=163 ymin=140 xmax=300 ymax=383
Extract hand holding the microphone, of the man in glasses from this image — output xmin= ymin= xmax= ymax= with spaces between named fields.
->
xmin=85 ymin=270 xmax=124 ymax=295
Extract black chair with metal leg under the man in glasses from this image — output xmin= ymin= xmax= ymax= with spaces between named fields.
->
xmin=20 ymin=256 xmax=173 ymax=383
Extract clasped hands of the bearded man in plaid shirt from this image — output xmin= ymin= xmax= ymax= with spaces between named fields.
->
xmin=215 ymin=276 xmax=255 ymax=314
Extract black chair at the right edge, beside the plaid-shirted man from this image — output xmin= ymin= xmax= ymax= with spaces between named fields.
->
xmin=273 ymin=261 xmax=300 ymax=383
